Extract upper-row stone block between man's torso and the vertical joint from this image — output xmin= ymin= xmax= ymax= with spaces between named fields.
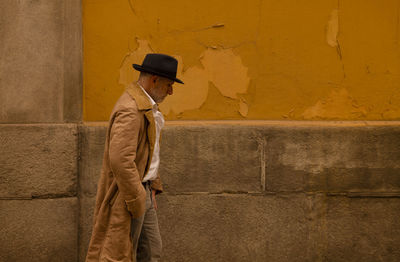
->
xmin=160 ymin=126 xmax=262 ymax=192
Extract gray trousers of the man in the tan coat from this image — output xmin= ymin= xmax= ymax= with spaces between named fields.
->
xmin=131 ymin=183 xmax=162 ymax=262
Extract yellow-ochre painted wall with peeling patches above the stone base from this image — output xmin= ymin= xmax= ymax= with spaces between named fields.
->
xmin=83 ymin=0 xmax=400 ymax=121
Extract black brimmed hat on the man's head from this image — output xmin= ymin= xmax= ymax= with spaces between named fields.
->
xmin=132 ymin=54 xmax=183 ymax=84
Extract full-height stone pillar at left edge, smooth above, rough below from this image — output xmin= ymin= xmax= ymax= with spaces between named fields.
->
xmin=0 ymin=0 xmax=82 ymax=261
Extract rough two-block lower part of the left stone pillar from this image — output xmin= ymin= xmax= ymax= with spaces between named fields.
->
xmin=0 ymin=124 xmax=79 ymax=262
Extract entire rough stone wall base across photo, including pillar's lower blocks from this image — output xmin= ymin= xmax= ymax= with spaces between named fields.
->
xmin=0 ymin=122 xmax=400 ymax=261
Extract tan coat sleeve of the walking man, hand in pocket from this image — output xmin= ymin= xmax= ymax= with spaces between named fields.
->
xmin=109 ymin=109 xmax=146 ymax=218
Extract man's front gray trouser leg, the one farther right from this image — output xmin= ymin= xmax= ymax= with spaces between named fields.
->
xmin=136 ymin=185 xmax=162 ymax=262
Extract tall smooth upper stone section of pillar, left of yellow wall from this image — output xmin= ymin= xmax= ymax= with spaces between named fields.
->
xmin=0 ymin=0 xmax=82 ymax=123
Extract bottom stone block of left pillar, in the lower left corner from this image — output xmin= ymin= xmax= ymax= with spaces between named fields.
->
xmin=0 ymin=197 xmax=78 ymax=262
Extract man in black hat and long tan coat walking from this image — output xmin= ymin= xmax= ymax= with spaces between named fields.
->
xmin=86 ymin=54 xmax=183 ymax=262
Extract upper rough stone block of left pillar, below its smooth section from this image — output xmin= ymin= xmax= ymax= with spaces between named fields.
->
xmin=0 ymin=124 xmax=78 ymax=198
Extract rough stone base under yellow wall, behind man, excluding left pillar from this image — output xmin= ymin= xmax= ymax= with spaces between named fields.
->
xmin=79 ymin=121 xmax=400 ymax=262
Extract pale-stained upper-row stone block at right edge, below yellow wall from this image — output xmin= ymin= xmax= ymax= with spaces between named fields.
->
xmin=260 ymin=126 xmax=400 ymax=192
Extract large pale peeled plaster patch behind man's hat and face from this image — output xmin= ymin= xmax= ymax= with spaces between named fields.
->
xmin=119 ymin=39 xmax=250 ymax=117
